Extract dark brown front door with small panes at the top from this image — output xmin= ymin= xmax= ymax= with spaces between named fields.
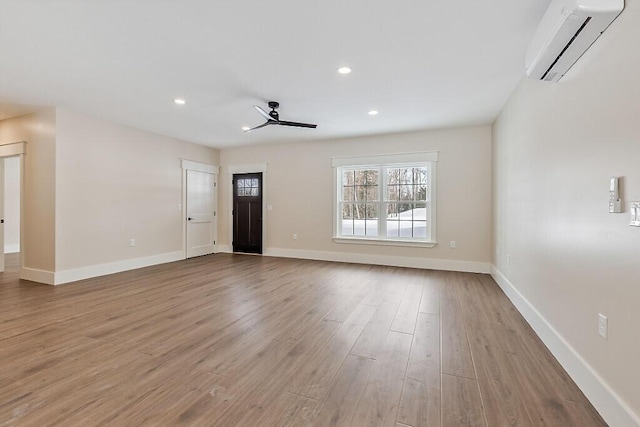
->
xmin=233 ymin=173 xmax=262 ymax=254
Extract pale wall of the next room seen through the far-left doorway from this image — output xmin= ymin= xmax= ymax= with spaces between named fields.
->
xmin=4 ymin=157 xmax=20 ymax=253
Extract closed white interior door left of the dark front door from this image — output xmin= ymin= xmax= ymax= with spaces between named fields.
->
xmin=186 ymin=170 xmax=217 ymax=258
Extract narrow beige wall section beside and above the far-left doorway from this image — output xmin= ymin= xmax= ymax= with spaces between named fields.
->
xmin=0 ymin=109 xmax=56 ymax=272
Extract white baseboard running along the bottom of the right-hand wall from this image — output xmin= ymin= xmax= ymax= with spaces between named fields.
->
xmin=491 ymin=265 xmax=640 ymax=427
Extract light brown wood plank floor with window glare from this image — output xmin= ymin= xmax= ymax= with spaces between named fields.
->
xmin=0 ymin=254 xmax=606 ymax=427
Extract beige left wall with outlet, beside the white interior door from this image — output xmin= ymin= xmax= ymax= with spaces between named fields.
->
xmin=56 ymin=109 xmax=219 ymax=271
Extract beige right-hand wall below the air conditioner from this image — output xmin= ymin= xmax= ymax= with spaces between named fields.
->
xmin=493 ymin=0 xmax=640 ymax=422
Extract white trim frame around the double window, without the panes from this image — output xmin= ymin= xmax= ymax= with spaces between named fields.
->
xmin=331 ymin=151 xmax=438 ymax=248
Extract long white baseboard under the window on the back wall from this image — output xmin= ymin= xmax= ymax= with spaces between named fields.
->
xmin=264 ymin=248 xmax=490 ymax=274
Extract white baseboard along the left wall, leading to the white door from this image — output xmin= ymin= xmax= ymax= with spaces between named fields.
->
xmin=54 ymin=251 xmax=184 ymax=285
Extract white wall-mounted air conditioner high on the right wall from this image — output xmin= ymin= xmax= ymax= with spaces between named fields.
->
xmin=527 ymin=0 xmax=624 ymax=82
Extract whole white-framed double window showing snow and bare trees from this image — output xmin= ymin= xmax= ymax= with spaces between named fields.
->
xmin=333 ymin=152 xmax=438 ymax=247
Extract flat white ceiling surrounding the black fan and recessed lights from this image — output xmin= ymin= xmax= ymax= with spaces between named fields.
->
xmin=0 ymin=0 xmax=550 ymax=147
